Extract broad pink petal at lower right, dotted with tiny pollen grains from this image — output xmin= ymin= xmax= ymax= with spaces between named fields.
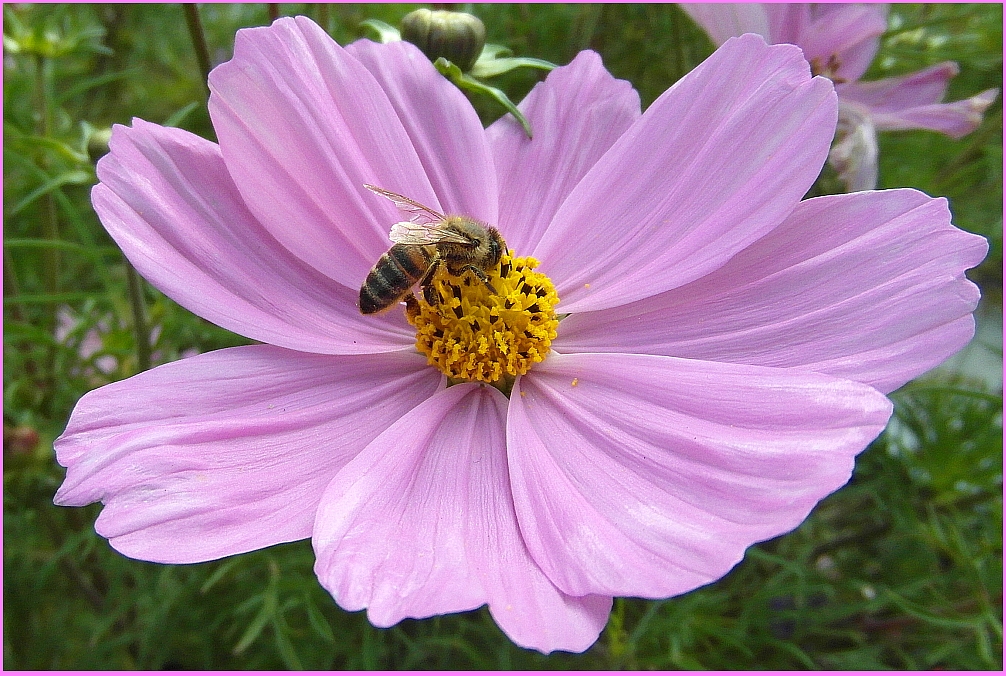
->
xmin=507 ymin=354 xmax=891 ymax=598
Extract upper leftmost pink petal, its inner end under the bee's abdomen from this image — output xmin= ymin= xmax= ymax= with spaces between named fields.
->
xmin=92 ymin=120 xmax=412 ymax=353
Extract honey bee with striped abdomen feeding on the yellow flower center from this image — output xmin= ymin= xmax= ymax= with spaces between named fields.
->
xmin=360 ymin=185 xmax=506 ymax=315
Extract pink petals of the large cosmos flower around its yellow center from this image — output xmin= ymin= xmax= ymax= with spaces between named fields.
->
xmin=55 ymin=18 xmax=987 ymax=652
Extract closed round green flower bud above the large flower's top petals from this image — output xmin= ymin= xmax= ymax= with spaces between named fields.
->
xmin=401 ymin=9 xmax=486 ymax=72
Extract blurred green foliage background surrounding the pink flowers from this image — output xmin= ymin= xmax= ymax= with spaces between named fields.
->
xmin=3 ymin=4 xmax=1003 ymax=670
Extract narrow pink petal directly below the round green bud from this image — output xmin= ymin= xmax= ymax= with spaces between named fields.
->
xmin=346 ymin=40 xmax=498 ymax=223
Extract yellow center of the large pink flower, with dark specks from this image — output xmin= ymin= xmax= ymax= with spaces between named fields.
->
xmin=406 ymin=251 xmax=559 ymax=392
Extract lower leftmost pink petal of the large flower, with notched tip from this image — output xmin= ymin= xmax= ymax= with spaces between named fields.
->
xmin=54 ymin=345 xmax=442 ymax=563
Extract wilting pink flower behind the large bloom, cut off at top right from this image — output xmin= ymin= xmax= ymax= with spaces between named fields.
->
xmin=682 ymin=3 xmax=999 ymax=190
